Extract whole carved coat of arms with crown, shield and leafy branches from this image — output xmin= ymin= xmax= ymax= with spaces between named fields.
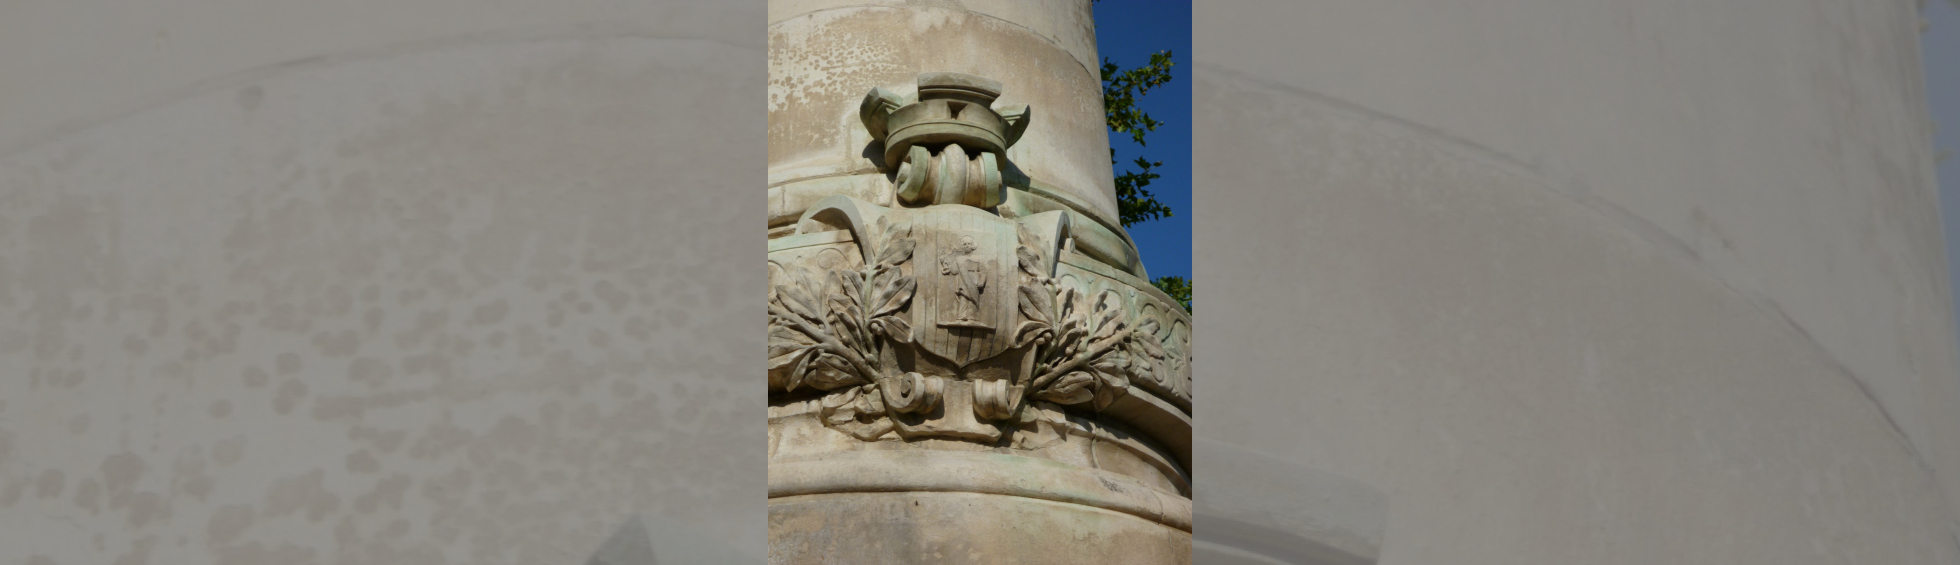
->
xmin=768 ymin=73 xmax=1190 ymax=449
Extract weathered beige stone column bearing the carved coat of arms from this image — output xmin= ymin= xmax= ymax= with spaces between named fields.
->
xmin=768 ymin=0 xmax=1192 ymax=563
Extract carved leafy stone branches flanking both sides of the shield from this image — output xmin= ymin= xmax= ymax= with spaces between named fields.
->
xmin=768 ymin=218 xmax=1186 ymax=445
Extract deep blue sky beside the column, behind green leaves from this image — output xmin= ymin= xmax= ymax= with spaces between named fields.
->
xmin=1096 ymin=0 xmax=1196 ymax=282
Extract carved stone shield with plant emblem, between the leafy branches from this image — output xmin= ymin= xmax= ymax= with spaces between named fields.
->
xmin=911 ymin=206 xmax=1019 ymax=367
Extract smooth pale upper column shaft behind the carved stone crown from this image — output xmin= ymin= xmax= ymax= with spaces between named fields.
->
xmin=768 ymin=2 xmax=1129 ymax=251
